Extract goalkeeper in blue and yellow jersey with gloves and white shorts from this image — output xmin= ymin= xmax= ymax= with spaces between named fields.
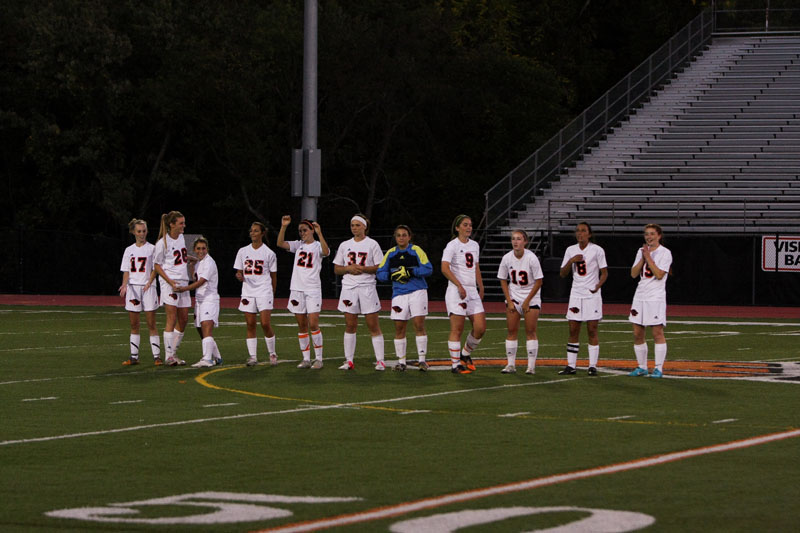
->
xmin=376 ymin=224 xmax=433 ymax=371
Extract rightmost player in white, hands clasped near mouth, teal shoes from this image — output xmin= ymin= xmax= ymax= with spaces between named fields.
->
xmin=628 ymin=224 xmax=672 ymax=378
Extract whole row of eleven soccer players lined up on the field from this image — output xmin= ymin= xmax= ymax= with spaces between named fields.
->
xmin=119 ymin=211 xmax=672 ymax=378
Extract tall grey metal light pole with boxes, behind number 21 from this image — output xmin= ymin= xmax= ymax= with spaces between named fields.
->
xmin=292 ymin=0 xmax=322 ymax=220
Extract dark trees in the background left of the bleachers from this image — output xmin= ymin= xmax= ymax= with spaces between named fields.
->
xmin=0 ymin=0 xmax=704 ymax=236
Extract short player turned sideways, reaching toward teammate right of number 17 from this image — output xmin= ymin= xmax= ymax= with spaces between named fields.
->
xmin=175 ymin=237 xmax=222 ymax=368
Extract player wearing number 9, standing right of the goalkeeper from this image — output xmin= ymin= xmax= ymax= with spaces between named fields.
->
xmin=442 ymin=215 xmax=486 ymax=374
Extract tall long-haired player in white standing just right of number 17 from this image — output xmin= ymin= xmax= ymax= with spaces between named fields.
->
xmin=154 ymin=211 xmax=192 ymax=366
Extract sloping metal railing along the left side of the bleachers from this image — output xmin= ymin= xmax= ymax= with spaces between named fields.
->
xmin=479 ymin=9 xmax=714 ymax=239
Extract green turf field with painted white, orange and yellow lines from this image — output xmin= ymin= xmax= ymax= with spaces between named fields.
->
xmin=0 ymin=306 xmax=800 ymax=532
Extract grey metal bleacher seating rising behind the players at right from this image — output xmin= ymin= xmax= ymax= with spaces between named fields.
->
xmin=506 ymin=36 xmax=800 ymax=235
